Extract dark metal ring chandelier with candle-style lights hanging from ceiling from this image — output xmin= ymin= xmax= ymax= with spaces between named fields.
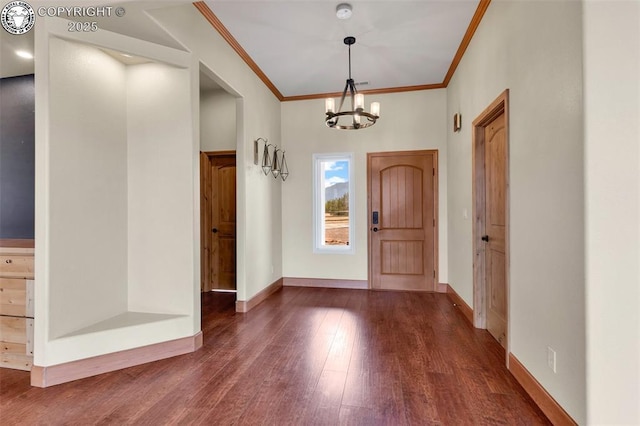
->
xmin=325 ymin=36 xmax=380 ymax=130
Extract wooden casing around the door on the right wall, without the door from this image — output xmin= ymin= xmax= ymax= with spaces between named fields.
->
xmin=472 ymin=89 xmax=511 ymax=364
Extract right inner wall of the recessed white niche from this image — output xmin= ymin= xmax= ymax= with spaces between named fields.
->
xmin=126 ymin=63 xmax=194 ymax=314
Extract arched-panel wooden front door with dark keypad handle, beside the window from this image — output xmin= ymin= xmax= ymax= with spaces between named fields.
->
xmin=367 ymin=151 xmax=437 ymax=291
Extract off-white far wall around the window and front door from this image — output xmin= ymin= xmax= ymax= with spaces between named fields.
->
xmin=282 ymin=90 xmax=448 ymax=283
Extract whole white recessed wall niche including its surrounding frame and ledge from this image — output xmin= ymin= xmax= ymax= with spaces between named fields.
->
xmin=34 ymin=18 xmax=200 ymax=367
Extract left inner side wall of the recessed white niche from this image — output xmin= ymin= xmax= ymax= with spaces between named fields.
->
xmin=47 ymin=38 xmax=127 ymax=338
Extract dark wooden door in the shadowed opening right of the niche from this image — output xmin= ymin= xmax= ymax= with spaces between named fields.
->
xmin=200 ymin=152 xmax=236 ymax=291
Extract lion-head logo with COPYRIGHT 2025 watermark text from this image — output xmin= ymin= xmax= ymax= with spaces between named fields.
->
xmin=0 ymin=0 xmax=127 ymax=35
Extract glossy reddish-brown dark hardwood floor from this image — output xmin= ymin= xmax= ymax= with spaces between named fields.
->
xmin=0 ymin=287 xmax=549 ymax=426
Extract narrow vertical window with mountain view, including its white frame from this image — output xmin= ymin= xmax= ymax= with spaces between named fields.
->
xmin=313 ymin=154 xmax=355 ymax=254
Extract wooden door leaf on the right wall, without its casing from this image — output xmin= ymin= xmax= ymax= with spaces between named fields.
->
xmin=482 ymin=112 xmax=507 ymax=346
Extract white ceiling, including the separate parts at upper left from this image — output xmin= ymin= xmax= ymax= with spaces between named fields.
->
xmin=0 ymin=0 xmax=479 ymax=98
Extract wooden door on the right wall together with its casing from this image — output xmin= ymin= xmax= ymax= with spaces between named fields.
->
xmin=473 ymin=92 xmax=509 ymax=349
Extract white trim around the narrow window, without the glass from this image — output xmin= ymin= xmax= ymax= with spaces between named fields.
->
xmin=312 ymin=152 xmax=356 ymax=254
